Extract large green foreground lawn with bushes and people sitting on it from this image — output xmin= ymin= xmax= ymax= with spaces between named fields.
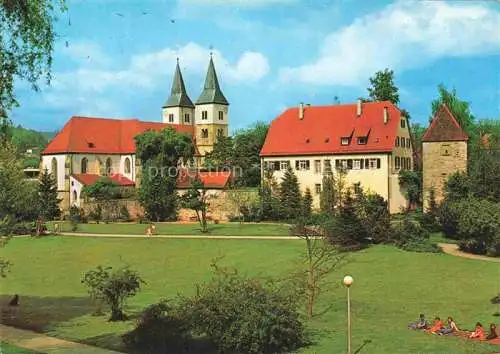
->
xmin=0 ymin=237 xmax=500 ymax=354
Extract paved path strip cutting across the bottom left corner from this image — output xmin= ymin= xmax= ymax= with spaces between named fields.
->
xmin=0 ymin=324 xmax=124 ymax=354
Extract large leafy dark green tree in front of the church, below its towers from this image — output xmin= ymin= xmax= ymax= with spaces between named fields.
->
xmin=135 ymin=127 xmax=194 ymax=221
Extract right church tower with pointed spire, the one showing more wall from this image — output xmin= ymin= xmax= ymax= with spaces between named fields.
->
xmin=195 ymin=55 xmax=229 ymax=156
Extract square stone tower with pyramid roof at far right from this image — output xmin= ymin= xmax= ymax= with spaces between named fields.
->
xmin=422 ymin=104 xmax=468 ymax=210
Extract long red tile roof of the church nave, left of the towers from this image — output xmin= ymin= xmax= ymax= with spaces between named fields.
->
xmin=42 ymin=117 xmax=193 ymax=155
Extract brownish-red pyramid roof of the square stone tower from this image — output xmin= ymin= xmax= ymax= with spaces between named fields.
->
xmin=422 ymin=104 xmax=469 ymax=142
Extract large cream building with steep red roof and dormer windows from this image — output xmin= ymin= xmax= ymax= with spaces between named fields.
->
xmin=261 ymin=101 xmax=413 ymax=213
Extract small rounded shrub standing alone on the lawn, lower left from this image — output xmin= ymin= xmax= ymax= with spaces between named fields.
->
xmin=81 ymin=266 xmax=144 ymax=321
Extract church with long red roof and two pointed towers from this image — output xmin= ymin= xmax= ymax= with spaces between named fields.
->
xmin=41 ymin=56 xmax=229 ymax=211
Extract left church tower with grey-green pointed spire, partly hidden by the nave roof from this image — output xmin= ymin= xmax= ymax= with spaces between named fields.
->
xmin=162 ymin=59 xmax=194 ymax=125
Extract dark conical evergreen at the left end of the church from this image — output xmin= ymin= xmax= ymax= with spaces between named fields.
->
xmin=38 ymin=169 xmax=62 ymax=220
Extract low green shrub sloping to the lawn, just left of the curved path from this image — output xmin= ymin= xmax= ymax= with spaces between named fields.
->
xmin=396 ymin=215 xmax=441 ymax=253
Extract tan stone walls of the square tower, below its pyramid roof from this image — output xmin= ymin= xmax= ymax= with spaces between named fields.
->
xmin=422 ymin=141 xmax=467 ymax=209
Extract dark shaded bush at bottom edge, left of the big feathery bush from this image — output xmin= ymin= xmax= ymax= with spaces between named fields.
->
xmin=123 ymin=301 xmax=191 ymax=354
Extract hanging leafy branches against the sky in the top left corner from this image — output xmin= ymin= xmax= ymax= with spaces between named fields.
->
xmin=0 ymin=0 xmax=66 ymax=111
